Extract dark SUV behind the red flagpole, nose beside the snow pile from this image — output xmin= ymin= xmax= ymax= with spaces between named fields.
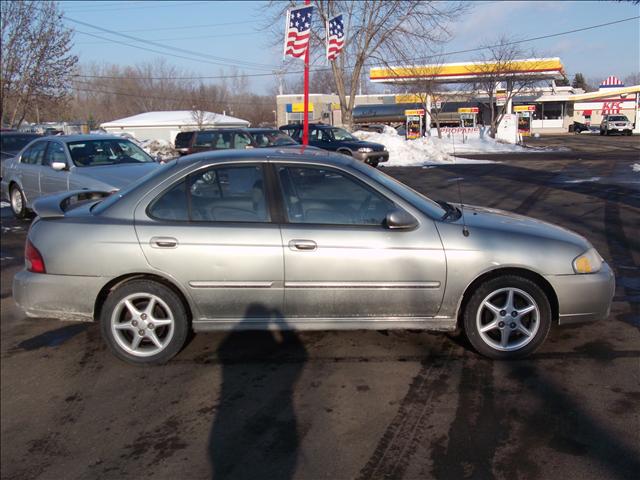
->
xmin=280 ymin=123 xmax=389 ymax=167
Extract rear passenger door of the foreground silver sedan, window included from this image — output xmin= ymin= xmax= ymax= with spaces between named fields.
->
xmin=135 ymin=164 xmax=284 ymax=326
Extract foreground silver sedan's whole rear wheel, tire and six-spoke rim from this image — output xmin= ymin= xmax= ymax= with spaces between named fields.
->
xmin=100 ymin=280 xmax=189 ymax=365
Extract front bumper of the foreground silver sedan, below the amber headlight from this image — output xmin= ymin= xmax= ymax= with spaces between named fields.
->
xmin=545 ymin=262 xmax=616 ymax=325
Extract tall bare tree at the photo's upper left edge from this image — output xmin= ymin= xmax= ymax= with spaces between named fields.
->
xmin=0 ymin=0 xmax=78 ymax=127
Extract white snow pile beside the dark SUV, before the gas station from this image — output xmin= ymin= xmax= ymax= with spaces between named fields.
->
xmin=353 ymin=127 xmax=527 ymax=167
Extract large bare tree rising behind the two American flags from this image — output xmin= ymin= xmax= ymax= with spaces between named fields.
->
xmin=269 ymin=0 xmax=466 ymax=128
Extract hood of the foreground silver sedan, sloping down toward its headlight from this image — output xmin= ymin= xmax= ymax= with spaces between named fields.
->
xmin=459 ymin=205 xmax=591 ymax=250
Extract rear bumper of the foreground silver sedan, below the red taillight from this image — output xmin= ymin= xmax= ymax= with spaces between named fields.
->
xmin=13 ymin=270 xmax=109 ymax=321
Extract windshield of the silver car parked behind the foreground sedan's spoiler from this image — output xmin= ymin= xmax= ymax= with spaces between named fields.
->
xmin=67 ymin=139 xmax=155 ymax=167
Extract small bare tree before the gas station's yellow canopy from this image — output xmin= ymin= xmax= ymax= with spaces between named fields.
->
xmin=470 ymin=37 xmax=540 ymax=138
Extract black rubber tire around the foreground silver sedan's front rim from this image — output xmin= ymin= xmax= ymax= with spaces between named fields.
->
xmin=463 ymin=275 xmax=552 ymax=360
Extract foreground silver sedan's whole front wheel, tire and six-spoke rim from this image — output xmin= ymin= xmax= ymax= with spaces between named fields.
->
xmin=463 ymin=275 xmax=552 ymax=360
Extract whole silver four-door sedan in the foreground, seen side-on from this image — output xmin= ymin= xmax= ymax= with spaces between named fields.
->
xmin=13 ymin=147 xmax=614 ymax=363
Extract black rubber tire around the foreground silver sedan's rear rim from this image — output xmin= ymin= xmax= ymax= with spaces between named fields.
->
xmin=100 ymin=280 xmax=190 ymax=365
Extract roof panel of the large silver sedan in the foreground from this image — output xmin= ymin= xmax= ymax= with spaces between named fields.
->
xmin=177 ymin=145 xmax=356 ymax=167
